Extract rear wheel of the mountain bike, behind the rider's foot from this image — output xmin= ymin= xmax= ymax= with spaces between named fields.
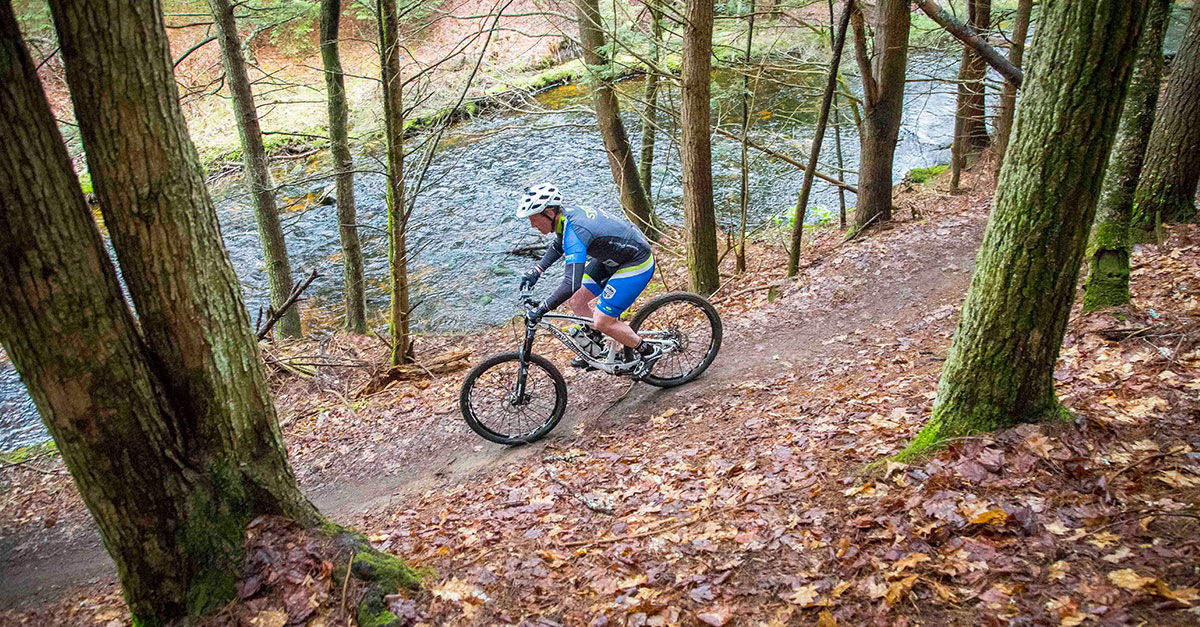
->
xmin=626 ymin=292 xmax=721 ymax=388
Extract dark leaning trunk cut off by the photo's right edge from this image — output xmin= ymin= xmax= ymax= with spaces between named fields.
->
xmin=1133 ymin=8 xmax=1200 ymax=236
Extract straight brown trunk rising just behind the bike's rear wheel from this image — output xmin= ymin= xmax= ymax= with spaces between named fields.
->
xmin=679 ymin=0 xmax=720 ymax=294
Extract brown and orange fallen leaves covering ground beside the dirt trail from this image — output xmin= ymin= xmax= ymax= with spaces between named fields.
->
xmin=0 ymin=166 xmax=1200 ymax=626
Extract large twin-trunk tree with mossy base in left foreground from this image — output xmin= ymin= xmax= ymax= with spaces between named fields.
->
xmin=25 ymin=0 xmax=322 ymax=625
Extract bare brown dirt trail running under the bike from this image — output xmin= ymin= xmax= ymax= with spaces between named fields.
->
xmin=0 ymin=202 xmax=986 ymax=610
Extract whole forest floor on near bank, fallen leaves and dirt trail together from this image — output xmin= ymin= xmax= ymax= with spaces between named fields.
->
xmin=0 ymin=163 xmax=1200 ymax=626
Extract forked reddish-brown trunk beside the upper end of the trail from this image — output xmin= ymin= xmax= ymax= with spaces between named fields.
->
xmin=851 ymin=0 xmax=911 ymax=229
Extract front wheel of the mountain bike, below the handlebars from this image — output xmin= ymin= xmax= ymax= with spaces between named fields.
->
xmin=458 ymin=352 xmax=566 ymax=444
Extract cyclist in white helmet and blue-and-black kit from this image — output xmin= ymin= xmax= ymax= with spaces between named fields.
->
xmin=516 ymin=184 xmax=662 ymax=380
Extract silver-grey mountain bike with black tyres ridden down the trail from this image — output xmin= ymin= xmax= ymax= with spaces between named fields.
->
xmin=458 ymin=292 xmax=721 ymax=444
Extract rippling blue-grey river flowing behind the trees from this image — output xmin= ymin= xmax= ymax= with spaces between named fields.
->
xmin=0 ymin=42 xmax=1089 ymax=450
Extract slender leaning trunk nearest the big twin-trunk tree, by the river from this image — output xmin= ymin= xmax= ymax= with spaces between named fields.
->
xmin=209 ymin=0 xmax=300 ymax=338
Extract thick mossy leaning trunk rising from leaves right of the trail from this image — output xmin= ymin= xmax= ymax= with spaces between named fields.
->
xmin=901 ymin=0 xmax=1148 ymax=458
